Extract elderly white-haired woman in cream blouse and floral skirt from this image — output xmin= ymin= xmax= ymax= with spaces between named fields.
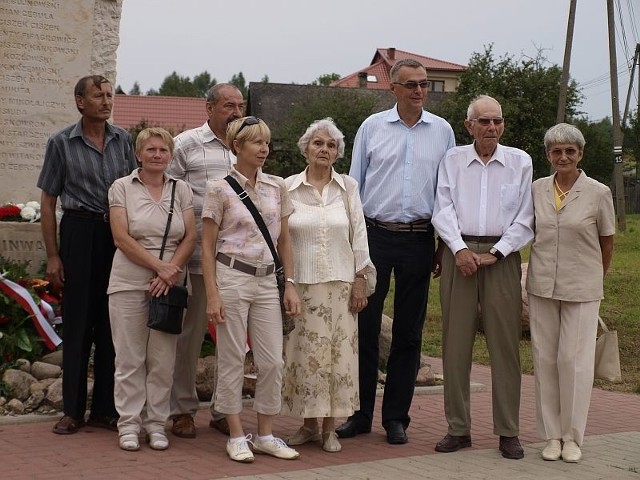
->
xmin=282 ymin=118 xmax=375 ymax=452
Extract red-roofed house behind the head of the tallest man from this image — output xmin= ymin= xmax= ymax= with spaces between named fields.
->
xmin=331 ymin=48 xmax=467 ymax=92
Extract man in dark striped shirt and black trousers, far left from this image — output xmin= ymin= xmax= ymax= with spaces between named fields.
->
xmin=38 ymin=75 xmax=136 ymax=434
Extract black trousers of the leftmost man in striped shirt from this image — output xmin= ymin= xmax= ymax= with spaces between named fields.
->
xmin=60 ymin=216 xmax=118 ymax=418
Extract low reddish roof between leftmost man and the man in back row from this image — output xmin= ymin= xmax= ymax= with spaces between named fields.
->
xmin=113 ymin=94 xmax=207 ymax=135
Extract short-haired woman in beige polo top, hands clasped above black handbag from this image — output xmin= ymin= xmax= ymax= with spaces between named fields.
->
xmin=107 ymin=128 xmax=196 ymax=450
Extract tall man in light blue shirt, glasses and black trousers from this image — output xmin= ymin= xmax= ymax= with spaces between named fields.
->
xmin=336 ymin=59 xmax=455 ymax=444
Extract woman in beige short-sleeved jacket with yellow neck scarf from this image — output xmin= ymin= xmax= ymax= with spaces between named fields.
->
xmin=527 ymin=123 xmax=615 ymax=463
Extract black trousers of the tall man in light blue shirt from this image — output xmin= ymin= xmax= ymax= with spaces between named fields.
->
xmin=353 ymin=224 xmax=434 ymax=428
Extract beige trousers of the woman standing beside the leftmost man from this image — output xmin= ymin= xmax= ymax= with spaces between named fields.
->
xmin=109 ymin=290 xmax=178 ymax=435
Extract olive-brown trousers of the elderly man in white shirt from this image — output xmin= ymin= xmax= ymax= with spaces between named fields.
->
xmin=440 ymin=246 xmax=522 ymax=437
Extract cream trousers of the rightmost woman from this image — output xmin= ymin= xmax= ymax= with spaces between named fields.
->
xmin=529 ymin=294 xmax=600 ymax=445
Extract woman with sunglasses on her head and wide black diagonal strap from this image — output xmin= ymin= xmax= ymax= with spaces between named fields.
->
xmin=202 ymin=117 xmax=301 ymax=463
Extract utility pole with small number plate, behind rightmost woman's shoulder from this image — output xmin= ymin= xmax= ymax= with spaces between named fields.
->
xmin=607 ymin=0 xmax=627 ymax=232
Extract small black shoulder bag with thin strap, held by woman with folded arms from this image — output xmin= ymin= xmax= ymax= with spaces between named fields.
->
xmin=147 ymin=180 xmax=189 ymax=335
